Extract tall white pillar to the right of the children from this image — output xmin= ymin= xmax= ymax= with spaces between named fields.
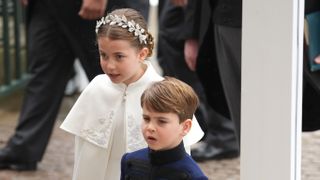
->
xmin=240 ymin=0 xmax=304 ymax=180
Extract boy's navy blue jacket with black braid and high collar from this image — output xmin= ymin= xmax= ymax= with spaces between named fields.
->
xmin=121 ymin=143 xmax=208 ymax=180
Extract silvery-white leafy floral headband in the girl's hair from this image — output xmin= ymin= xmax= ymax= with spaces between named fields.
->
xmin=96 ymin=14 xmax=148 ymax=44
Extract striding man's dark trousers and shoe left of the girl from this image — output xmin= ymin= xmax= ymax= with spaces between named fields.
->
xmin=0 ymin=0 xmax=103 ymax=170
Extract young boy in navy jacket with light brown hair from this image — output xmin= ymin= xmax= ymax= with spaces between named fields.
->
xmin=121 ymin=77 xmax=208 ymax=180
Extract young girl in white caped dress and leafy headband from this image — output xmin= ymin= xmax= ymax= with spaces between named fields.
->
xmin=61 ymin=9 xmax=203 ymax=180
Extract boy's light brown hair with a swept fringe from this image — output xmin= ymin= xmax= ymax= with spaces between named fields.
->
xmin=141 ymin=77 xmax=199 ymax=123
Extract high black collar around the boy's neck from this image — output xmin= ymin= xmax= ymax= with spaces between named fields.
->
xmin=149 ymin=141 xmax=186 ymax=165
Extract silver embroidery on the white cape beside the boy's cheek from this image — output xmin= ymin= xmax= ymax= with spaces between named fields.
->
xmin=127 ymin=115 xmax=147 ymax=152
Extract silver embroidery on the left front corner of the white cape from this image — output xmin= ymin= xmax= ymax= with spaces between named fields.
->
xmin=80 ymin=111 xmax=114 ymax=147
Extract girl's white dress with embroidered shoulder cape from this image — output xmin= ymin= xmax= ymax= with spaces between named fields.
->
xmin=61 ymin=62 xmax=204 ymax=180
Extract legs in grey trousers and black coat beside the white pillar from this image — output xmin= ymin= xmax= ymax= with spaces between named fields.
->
xmin=186 ymin=0 xmax=242 ymax=160
